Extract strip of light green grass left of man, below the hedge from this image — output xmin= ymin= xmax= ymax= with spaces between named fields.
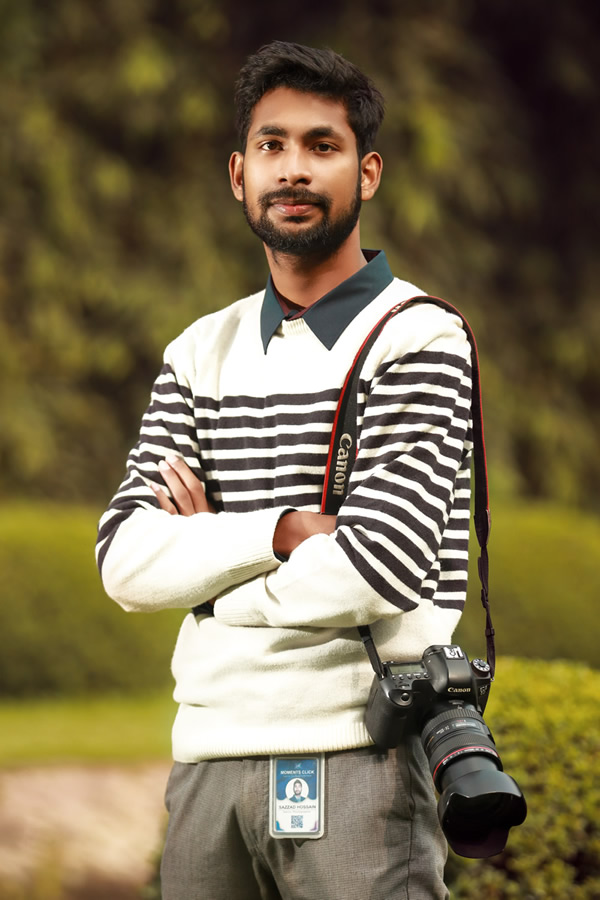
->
xmin=0 ymin=691 xmax=176 ymax=768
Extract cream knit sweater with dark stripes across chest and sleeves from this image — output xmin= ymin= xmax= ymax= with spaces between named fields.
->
xmin=97 ymin=254 xmax=471 ymax=762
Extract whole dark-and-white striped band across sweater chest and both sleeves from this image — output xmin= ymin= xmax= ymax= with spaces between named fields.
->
xmin=98 ymin=311 xmax=471 ymax=611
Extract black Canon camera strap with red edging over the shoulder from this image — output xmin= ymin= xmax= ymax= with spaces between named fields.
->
xmin=321 ymin=294 xmax=496 ymax=678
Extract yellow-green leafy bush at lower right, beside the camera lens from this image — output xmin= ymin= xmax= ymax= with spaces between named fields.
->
xmin=447 ymin=658 xmax=600 ymax=900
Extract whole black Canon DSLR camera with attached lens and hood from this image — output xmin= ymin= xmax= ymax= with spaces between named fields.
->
xmin=365 ymin=644 xmax=527 ymax=859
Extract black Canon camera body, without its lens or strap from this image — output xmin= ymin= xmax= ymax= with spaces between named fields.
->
xmin=365 ymin=644 xmax=491 ymax=748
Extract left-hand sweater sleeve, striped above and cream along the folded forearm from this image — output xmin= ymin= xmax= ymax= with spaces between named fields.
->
xmin=96 ymin=345 xmax=289 ymax=611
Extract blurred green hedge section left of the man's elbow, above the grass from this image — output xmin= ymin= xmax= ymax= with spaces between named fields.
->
xmin=0 ymin=505 xmax=183 ymax=697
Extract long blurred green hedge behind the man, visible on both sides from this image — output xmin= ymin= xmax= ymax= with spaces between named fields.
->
xmin=0 ymin=504 xmax=600 ymax=696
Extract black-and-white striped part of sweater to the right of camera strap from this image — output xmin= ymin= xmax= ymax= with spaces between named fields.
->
xmin=338 ymin=351 xmax=472 ymax=610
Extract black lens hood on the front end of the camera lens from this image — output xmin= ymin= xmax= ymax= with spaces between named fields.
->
xmin=438 ymin=766 xmax=527 ymax=859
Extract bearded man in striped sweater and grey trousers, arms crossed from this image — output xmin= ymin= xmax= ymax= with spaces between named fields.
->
xmin=98 ymin=42 xmax=471 ymax=900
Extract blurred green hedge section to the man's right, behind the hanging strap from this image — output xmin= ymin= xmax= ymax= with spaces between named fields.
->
xmin=454 ymin=503 xmax=600 ymax=668
